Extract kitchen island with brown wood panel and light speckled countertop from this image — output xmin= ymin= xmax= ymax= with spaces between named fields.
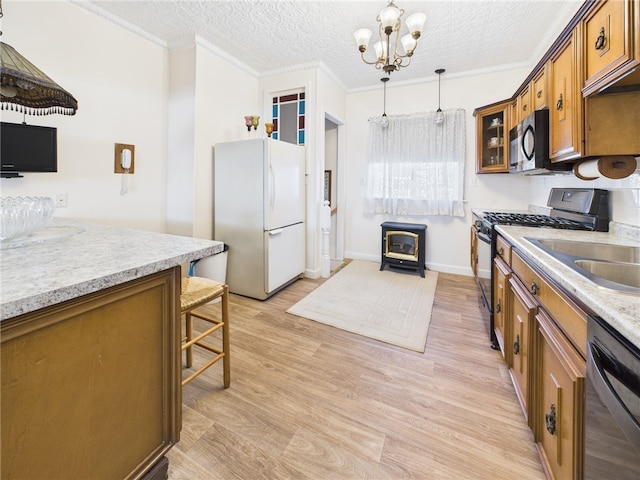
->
xmin=0 ymin=219 xmax=224 ymax=479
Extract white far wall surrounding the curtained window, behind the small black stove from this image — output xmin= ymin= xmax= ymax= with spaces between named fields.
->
xmin=345 ymin=69 xmax=530 ymax=274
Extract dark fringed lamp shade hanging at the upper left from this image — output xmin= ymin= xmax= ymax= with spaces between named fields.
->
xmin=0 ymin=42 xmax=78 ymax=115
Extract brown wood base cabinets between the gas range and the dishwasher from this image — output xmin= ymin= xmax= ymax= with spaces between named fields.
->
xmin=494 ymin=237 xmax=587 ymax=480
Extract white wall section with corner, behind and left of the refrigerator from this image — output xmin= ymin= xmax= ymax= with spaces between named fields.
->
xmin=167 ymin=39 xmax=266 ymax=239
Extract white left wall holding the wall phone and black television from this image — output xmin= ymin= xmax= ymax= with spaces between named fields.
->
xmin=0 ymin=0 xmax=168 ymax=231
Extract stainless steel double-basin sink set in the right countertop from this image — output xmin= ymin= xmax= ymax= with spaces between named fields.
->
xmin=524 ymin=237 xmax=640 ymax=294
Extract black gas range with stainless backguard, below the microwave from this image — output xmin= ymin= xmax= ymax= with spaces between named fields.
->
xmin=472 ymin=188 xmax=609 ymax=350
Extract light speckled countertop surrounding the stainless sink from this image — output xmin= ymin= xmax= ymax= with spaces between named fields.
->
xmin=496 ymin=225 xmax=640 ymax=348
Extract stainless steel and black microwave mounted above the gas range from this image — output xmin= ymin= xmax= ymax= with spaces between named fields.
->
xmin=509 ymin=109 xmax=571 ymax=175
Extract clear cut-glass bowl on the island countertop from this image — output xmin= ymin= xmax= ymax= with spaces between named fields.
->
xmin=0 ymin=197 xmax=56 ymax=242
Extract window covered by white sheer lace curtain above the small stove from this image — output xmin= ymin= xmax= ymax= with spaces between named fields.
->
xmin=365 ymin=109 xmax=466 ymax=217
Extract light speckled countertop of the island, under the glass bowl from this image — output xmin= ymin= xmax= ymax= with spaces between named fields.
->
xmin=0 ymin=218 xmax=224 ymax=320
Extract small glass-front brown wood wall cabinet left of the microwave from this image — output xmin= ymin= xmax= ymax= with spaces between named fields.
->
xmin=474 ymin=103 xmax=510 ymax=173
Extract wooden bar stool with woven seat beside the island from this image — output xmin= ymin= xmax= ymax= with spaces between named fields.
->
xmin=180 ymin=277 xmax=231 ymax=388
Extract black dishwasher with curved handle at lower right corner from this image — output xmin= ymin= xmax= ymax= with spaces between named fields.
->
xmin=584 ymin=318 xmax=640 ymax=480
